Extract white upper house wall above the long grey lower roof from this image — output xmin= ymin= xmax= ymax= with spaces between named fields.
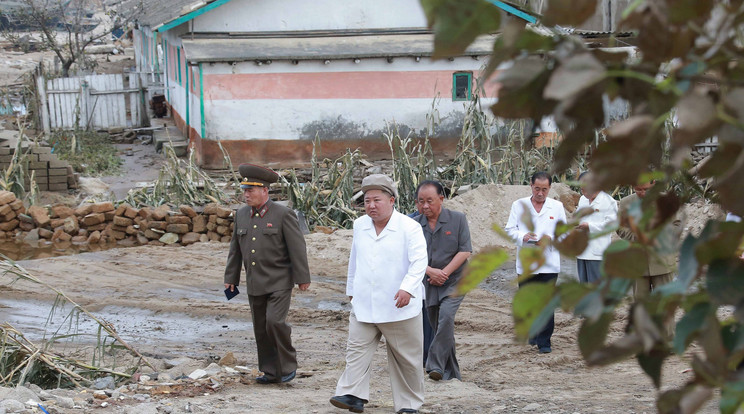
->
xmin=194 ymin=0 xmax=426 ymax=32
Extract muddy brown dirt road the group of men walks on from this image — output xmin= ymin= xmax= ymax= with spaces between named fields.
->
xmin=0 ymin=231 xmax=715 ymax=413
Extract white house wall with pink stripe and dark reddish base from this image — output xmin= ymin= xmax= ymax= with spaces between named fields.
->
xmin=192 ymin=57 xmax=495 ymax=167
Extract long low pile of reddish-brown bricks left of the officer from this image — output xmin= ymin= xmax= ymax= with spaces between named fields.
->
xmin=0 ymin=191 xmax=233 ymax=246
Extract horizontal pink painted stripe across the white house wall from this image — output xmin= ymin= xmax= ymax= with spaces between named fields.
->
xmin=204 ymin=71 xmax=468 ymax=100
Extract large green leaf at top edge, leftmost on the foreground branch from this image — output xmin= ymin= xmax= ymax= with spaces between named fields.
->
xmin=421 ymin=0 xmax=501 ymax=59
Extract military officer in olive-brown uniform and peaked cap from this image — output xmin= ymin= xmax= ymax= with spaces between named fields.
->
xmin=225 ymin=164 xmax=310 ymax=384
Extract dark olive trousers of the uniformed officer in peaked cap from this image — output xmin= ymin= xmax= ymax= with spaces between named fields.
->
xmin=248 ymin=289 xmax=297 ymax=379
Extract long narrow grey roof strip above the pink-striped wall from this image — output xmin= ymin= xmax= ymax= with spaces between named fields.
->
xmin=182 ymin=34 xmax=496 ymax=62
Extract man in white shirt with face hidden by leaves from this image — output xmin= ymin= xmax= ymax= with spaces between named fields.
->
xmin=576 ymin=171 xmax=617 ymax=283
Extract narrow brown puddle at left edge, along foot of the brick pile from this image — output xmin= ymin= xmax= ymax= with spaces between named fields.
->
xmin=0 ymin=240 xmax=121 ymax=261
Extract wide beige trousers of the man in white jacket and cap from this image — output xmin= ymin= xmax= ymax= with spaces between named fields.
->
xmin=336 ymin=312 xmax=424 ymax=411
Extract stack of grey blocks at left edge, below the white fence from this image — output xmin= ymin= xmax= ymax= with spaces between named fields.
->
xmin=0 ymin=146 xmax=78 ymax=191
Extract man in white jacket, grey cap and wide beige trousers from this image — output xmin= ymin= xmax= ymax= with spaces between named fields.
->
xmin=331 ymin=174 xmax=427 ymax=413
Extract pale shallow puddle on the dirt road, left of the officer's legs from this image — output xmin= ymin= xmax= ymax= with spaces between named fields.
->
xmin=0 ymin=298 xmax=253 ymax=345
